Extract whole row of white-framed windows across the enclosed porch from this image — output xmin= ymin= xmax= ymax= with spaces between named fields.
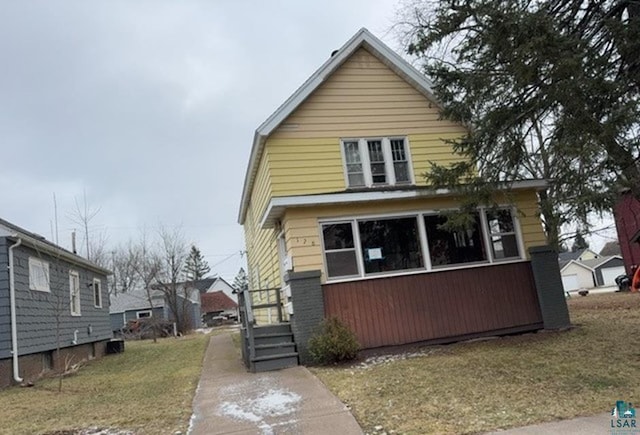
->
xmin=320 ymin=208 xmax=521 ymax=280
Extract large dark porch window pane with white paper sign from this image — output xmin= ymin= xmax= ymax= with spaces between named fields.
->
xmin=358 ymin=217 xmax=423 ymax=274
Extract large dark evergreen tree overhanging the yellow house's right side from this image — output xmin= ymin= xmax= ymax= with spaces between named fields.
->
xmin=407 ymin=0 xmax=640 ymax=248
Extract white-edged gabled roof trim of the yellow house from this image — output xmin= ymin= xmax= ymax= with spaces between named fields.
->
xmin=238 ymin=27 xmax=437 ymax=224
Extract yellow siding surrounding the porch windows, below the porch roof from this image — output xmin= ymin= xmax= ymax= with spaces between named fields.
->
xmin=283 ymin=190 xmax=545 ymax=280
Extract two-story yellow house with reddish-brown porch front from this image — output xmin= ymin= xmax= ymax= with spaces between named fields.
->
xmin=238 ymin=29 xmax=562 ymax=368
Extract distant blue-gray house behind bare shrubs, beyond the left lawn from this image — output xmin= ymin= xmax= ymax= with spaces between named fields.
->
xmin=109 ymin=283 xmax=202 ymax=332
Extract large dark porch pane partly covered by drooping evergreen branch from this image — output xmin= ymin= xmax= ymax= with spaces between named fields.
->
xmin=424 ymin=213 xmax=487 ymax=267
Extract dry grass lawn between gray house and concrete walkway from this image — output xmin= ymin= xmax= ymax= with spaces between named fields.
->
xmin=0 ymin=334 xmax=209 ymax=434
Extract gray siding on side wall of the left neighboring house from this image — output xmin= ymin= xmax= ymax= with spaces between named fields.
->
xmin=0 ymin=246 xmax=112 ymax=358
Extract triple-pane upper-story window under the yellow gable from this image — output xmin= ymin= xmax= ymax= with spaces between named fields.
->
xmin=342 ymin=138 xmax=412 ymax=188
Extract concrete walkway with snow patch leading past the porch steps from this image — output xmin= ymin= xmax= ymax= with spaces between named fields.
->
xmin=189 ymin=334 xmax=362 ymax=435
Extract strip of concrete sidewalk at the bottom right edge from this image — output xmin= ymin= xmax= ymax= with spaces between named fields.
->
xmin=487 ymin=412 xmax=616 ymax=435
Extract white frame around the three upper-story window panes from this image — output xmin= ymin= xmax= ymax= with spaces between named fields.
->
xmin=340 ymin=136 xmax=415 ymax=189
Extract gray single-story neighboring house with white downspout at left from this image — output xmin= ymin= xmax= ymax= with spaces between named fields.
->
xmin=0 ymin=219 xmax=113 ymax=388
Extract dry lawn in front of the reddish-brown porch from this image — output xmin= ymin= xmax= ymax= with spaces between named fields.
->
xmin=313 ymin=293 xmax=640 ymax=434
